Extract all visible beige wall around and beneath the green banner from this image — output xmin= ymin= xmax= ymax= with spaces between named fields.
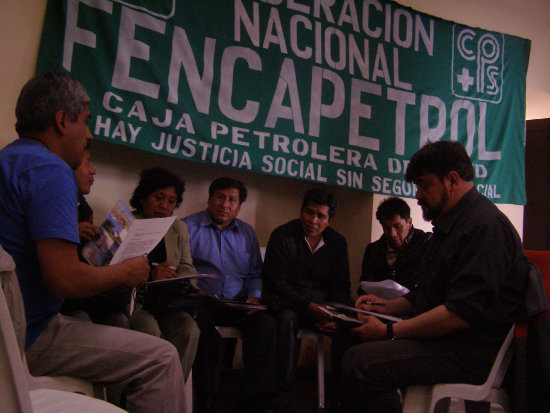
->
xmin=0 ymin=0 xmax=550 ymax=290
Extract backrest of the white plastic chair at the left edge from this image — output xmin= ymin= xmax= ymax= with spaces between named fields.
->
xmin=0 ymin=247 xmax=33 ymax=413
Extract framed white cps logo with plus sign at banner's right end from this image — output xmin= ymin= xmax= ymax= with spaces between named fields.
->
xmin=452 ymin=25 xmax=504 ymax=103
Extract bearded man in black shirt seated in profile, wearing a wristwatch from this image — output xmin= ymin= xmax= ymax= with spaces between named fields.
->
xmin=342 ymin=141 xmax=528 ymax=413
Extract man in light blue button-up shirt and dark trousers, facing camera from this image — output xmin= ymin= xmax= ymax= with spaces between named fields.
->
xmin=183 ymin=177 xmax=275 ymax=413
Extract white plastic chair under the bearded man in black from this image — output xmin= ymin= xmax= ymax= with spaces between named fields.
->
xmin=403 ymin=326 xmax=515 ymax=413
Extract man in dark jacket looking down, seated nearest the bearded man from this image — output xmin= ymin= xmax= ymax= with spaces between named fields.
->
xmin=359 ymin=197 xmax=431 ymax=295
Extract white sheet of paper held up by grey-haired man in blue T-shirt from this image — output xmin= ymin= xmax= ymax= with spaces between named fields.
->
xmin=110 ymin=216 xmax=177 ymax=265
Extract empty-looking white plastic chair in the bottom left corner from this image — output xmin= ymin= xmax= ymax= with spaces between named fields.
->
xmin=0 ymin=266 xmax=124 ymax=413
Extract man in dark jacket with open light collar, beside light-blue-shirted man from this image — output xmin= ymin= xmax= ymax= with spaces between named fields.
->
xmin=262 ymin=188 xmax=350 ymax=404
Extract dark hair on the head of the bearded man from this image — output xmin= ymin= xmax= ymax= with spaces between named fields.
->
xmin=405 ymin=141 xmax=474 ymax=182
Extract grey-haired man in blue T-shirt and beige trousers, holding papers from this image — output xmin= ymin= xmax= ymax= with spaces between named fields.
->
xmin=0 ymin=72 xmax=188 ymax=413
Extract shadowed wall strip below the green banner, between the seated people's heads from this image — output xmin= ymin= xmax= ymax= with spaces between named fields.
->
xmin=87 ymin=141 xmax=372 ymax=286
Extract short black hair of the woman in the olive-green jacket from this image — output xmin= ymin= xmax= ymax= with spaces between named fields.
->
xmin=130 ymin=167 xmax=185 ymax=212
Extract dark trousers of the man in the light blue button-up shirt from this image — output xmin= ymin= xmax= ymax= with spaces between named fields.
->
xmin=193 ymin=305 xmax=275 ymax=402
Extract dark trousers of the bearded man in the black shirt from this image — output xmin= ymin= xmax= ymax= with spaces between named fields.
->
xmin=342 ymin=337 xmax=499 ymax=413
